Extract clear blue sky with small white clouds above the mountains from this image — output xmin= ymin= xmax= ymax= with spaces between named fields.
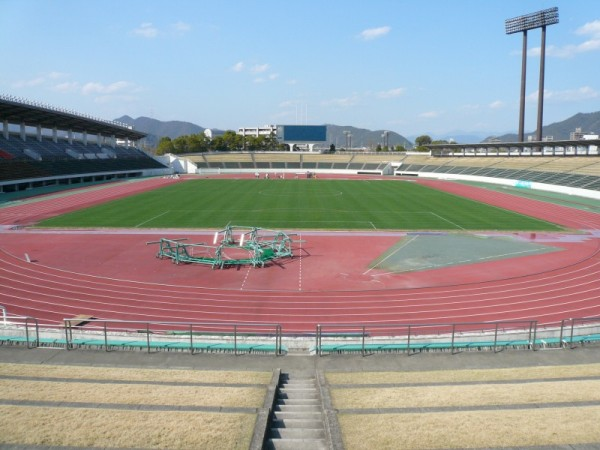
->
xmin=0 ymin=0 xmax=600 ymax=138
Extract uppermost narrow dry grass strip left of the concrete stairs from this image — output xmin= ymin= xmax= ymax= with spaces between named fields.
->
xmin=0 ymin=364 xmax=272 ymax=385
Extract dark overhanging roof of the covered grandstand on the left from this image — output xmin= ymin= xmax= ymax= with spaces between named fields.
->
xmin=0 ymin=95 xmax=146 ymax=140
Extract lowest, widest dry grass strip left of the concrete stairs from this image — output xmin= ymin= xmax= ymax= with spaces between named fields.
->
xmin=0 ymin=406 xmax=256 ymax=449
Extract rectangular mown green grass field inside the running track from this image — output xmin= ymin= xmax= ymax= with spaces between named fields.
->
xmin=39 ymin=179 xmax=561 ymax=231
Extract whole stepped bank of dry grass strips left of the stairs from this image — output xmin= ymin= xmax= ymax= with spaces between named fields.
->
xmin=0 ymin=364 xmax=272 ymax=449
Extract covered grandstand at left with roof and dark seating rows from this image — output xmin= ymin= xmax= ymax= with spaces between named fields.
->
xmin=0 ymin=96 xmax=169 ymax=193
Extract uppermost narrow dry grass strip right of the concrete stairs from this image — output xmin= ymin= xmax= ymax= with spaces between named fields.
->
xmin=326 ymin=364 xmax=600 ymax=384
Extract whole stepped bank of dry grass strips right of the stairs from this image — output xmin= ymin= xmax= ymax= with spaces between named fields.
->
xmin=326 ymin=364 xmax=600 ymax=450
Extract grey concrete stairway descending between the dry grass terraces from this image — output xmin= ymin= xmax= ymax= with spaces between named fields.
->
xmin=265 ymin=374 xmax=329 ymax=450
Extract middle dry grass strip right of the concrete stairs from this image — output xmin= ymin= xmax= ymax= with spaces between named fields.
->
xmin=331 ymin=380 xmax=600 ymax=409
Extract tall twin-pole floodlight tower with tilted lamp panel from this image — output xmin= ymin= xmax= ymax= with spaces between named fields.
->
xmin=504 ymin=7 xmax=558 ymax=142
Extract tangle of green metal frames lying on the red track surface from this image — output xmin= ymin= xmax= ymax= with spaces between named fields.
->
xmin=154 ymin=225 xmax=294 ymax=269
